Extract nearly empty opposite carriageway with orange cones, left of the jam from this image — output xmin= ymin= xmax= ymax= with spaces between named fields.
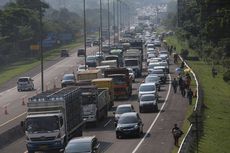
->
xmin=0 ymin=47 xmax=98 ymax=133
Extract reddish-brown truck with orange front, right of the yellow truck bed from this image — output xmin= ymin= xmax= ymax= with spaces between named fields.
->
xmin=104 ymin=68 xmax=132 ymax=99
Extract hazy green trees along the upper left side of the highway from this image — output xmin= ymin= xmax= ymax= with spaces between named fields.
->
xmin=0 ymin=0 xmax=82 ymax=64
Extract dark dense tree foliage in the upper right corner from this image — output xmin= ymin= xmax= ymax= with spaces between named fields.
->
xmin=165 ymin=0 xmax=230 ymax=66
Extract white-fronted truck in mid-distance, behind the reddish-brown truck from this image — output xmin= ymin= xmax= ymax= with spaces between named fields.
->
xmin=123 ymin=49 xmax=142 ymax=77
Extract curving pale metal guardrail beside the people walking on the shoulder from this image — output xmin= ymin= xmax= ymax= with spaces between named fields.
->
xmin=177 ymin=56 xmax=203 ymax=153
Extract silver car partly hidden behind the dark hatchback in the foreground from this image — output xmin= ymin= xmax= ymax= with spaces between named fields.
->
xmin=114 ymin=104 xmax=135 ymax=127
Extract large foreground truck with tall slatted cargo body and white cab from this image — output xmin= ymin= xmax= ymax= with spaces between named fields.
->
xmin=21 ymin=86 xmax=85 ymax=153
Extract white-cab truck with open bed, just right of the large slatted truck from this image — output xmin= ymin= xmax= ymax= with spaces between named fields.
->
xmin=79 ymin=85 xmax=110 ymax=123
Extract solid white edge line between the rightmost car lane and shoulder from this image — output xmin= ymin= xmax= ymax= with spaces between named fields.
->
xmin=132 ymin=75 xmax=171 ymax=153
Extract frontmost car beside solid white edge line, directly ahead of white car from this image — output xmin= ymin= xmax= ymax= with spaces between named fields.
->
xmin=139 ymin=94 xmax=158 ymax=113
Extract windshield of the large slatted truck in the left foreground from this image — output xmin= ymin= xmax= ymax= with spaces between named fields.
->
xmin=25 ymin=116 xmax=59 ymax=133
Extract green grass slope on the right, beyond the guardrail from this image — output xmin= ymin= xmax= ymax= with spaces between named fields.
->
xmin=167 ymin=37 xmax=230 ymax=153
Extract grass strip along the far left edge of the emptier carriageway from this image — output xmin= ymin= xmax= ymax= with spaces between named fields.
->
xmin=0 ymin=40 xmax=82 ymax=85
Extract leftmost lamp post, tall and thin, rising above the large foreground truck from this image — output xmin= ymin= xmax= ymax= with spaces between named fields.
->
xmin=39 ymin=1 xmax=44 ymax=92
